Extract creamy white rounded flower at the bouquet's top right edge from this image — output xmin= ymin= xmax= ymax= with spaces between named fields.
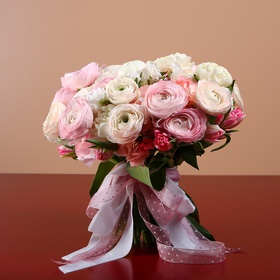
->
xmin=195 ymin=62 xmax=232 ymax=87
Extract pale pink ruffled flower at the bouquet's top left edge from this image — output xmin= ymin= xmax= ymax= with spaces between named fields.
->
xmin=61 ymin=62 xmax=100 ymax=89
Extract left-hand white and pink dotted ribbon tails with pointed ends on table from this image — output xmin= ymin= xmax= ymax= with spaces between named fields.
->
xmin=59 ymin=182 xmax=133 ymax=273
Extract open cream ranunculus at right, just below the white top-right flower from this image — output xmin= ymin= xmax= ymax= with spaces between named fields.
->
xmin=196 ymin=80 xmax=232 ymax=116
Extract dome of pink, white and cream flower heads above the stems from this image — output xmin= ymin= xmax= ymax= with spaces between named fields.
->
xmin=43 ymin=53 xmax=245 ymax=167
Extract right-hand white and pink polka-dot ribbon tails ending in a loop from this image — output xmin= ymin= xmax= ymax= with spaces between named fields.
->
xmin=137 ymin=180 xmax=228 ymax=264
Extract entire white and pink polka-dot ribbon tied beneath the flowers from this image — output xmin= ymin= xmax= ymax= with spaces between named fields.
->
xmin=59 ymin=163 xmax=226 ymax=273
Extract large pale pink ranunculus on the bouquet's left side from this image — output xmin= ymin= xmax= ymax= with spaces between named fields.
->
xmin=58 ymin=97 xmax=93 ymax=145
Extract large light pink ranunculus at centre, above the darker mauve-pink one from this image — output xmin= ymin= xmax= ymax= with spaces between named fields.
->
xmin=144 ymin=81 xmax=188 ymax=119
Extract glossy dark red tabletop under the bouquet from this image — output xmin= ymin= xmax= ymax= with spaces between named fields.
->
xmin=0 ymin=174 xmax=280 ymax=280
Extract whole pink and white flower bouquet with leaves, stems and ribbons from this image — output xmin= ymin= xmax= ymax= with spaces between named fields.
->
xmin=43 ymin=53 xmax=245 ymax=273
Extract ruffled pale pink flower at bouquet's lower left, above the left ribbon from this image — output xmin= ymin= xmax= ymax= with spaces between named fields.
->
xmin=75 ymin=134 xmax=96 ymax=167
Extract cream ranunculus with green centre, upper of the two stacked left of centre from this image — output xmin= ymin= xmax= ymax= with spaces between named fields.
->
xmin=106 ymin=77 xmax=140 ymax=105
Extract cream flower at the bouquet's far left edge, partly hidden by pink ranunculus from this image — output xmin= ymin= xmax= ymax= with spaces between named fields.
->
xmin=43 ymin=102 xmax=66 ymax=142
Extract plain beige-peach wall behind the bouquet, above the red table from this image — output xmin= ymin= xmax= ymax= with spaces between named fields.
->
xmin=0 ymin=0 xmax=280 ymax=175
